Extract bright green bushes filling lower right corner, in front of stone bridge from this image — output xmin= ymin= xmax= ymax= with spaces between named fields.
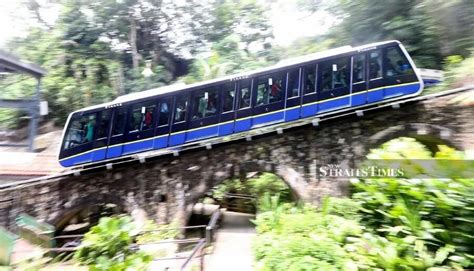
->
xmin=254 ymin=138 xmax=474 ymax=271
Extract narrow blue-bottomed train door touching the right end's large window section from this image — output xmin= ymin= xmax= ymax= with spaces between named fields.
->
xmin=366 ymin=49 xmax=384 ymax=103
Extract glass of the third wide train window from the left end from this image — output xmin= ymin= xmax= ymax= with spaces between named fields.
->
xmin=191 ymin=89 xmax=219 ymax=120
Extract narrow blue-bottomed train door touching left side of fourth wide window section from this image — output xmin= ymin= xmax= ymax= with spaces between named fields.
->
xmin=234 ymin=79 xmax=253 ymax=133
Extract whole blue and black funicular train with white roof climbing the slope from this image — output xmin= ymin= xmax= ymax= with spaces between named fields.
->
xmin=59 ymin=41 xmax=423 ymax=167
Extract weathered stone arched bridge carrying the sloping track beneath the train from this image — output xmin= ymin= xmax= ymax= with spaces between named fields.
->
xmin=0 ymin=89 xmax=474 ymax=234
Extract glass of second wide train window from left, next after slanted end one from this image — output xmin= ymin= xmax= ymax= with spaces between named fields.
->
xmin=128 ymin=102 xmax=156 ymax=133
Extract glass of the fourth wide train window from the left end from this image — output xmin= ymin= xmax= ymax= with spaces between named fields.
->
xmin=257 ymin=74 xmax=285 ymax=106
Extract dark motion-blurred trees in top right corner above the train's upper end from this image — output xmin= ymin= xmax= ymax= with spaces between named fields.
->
xmin=306 ymin=0 xmax=474 ymax=68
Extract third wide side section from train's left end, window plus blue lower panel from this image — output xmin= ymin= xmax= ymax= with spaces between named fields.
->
xmin=186 ymin=87 xmax=220 ymax=142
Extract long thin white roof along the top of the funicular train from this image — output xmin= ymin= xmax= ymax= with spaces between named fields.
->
xmin=75 ymin=40 xmax=400 ymax=112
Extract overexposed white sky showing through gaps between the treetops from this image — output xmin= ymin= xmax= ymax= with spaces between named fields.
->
xmin=0 ymin=0 xmax=334 ymax=46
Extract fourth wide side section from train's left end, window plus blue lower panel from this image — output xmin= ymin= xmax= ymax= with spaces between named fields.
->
xmin=252 ymin=72 xmax=286 ymax=127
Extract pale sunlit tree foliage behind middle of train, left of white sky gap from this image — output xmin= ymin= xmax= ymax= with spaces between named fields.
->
xmin=184 ymin=0 xmax=272 ymax=83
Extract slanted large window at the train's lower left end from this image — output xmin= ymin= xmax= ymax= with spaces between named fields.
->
xmin=63 ymin=113 xmax=97 ymax=150
